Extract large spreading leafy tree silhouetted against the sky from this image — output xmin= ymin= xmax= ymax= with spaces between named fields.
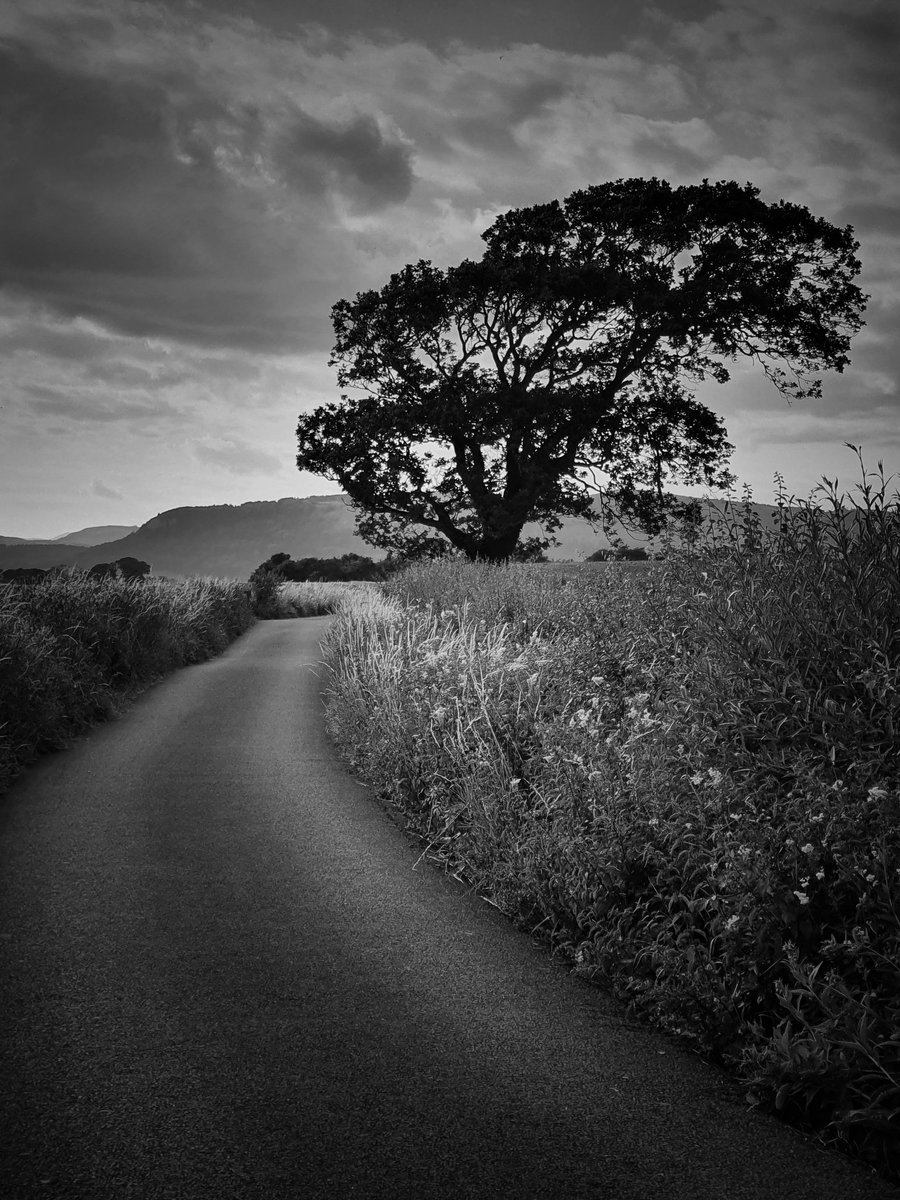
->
xmin=296 ymin=179 xmax=865 ymax=559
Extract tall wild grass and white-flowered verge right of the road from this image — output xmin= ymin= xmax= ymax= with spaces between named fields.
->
xmin=325 ymin=458 xmax=900 ymax=1178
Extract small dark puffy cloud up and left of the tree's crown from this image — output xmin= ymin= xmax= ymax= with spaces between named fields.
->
xmin=276 ymin=113 xmax=413 ymax=212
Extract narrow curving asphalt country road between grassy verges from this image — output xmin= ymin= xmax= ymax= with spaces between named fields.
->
xmin=0 ymin=618 xmax=898 ymax=1200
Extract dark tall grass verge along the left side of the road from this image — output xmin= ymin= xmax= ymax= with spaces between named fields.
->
xmin=0 ymin=572 xmax=254 ymax=792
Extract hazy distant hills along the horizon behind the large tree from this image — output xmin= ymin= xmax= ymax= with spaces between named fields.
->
xmin=0 ymin=496 xmax=775 ymax=580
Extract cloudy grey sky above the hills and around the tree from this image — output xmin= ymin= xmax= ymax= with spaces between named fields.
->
xmin=0 ymin=0 xmax=900 ymax=538
